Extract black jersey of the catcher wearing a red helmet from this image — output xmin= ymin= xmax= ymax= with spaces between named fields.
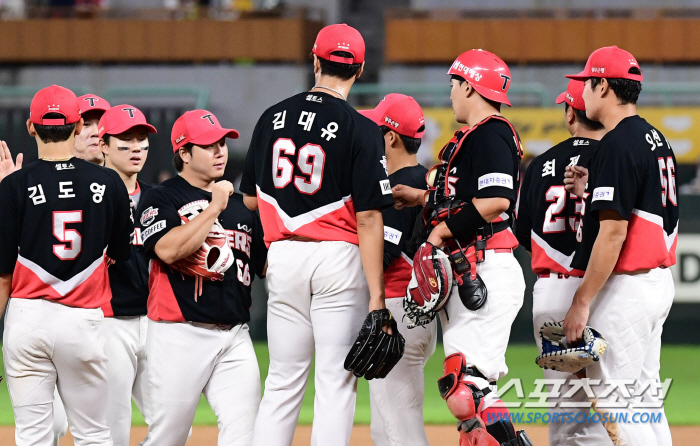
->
xmin=438 ymin=116 xmax=522 ymax=249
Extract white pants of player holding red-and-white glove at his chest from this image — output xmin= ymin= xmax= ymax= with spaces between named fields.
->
xmin=143 ymin=320 xmax=260 ymax=446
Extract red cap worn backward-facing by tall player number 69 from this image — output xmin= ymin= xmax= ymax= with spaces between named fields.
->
xmin=311 ymin=23 xmax=365 ymax=64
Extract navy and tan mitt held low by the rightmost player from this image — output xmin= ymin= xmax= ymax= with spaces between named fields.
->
xmin=535 ymin=322 xmax=608 ymax=373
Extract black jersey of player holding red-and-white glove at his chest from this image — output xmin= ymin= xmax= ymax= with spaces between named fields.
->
xmin=137 ymin=176 xmax=267 ymax=324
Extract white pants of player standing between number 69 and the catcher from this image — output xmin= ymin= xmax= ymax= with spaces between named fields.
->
xmin=369 ymin=298 xmax=437 ymax=446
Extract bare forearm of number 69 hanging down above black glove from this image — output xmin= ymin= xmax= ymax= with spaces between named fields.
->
xmin=357 ymin=209 xmax=385 ymax=310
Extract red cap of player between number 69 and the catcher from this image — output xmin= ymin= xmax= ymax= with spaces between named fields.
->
xmin=360 ymin=93 xmax=425 ymax=138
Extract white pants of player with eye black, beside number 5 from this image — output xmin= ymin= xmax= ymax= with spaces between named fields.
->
xmin=103 ymin=316 xmax=151 ymax=446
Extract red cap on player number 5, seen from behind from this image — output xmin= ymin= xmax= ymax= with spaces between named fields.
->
xmin=29 ymin=85 xmax=80 ymax=125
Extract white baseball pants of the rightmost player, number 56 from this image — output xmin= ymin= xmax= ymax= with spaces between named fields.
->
xmin=586 ymin=268 xmax=675 ymax=446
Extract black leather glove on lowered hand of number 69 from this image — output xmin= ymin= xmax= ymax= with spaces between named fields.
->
xmin=344 ymin=309 xmax=406 ymax=380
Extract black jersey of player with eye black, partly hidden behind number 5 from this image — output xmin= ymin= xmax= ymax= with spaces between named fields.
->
xmin=102 ymin=181 xmax=152 ymax=316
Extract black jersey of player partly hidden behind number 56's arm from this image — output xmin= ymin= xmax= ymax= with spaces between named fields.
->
xmin=515 ymin=138 xmax=598 ymax=277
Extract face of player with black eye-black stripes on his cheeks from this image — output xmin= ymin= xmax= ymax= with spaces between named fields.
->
xmin=100 ymin=127 xmax=148 ymax=176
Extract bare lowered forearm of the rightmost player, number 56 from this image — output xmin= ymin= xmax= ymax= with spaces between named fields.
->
xmin=573 ymin=220 xmax=627 ymax=306
